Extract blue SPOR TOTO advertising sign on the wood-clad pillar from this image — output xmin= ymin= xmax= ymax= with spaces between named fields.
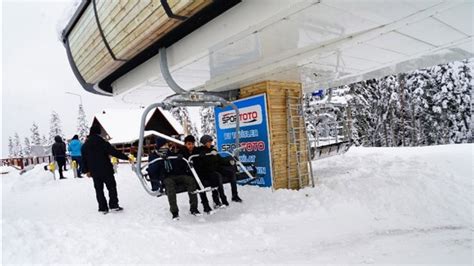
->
xmin=214 ymin=94 xmax=272 ymax=187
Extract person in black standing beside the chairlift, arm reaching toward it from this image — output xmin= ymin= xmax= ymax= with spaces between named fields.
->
xmin=81 ymin=125 xmax=129 ymax=214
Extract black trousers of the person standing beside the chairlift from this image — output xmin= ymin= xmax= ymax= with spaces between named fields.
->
xmin=92 ymin=175 xmax=119 ymax=211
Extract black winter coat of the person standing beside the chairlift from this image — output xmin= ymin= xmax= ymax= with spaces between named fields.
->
xmin=81 ymin=135 xmax=128 ymax=177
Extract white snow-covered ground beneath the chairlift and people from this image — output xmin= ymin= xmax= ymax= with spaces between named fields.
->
xmin=2 ymin=145 xmax=474 ymax=265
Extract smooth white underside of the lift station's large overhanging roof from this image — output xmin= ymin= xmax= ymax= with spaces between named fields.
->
xmin=113 ymin=0 xmax=474 ymax=104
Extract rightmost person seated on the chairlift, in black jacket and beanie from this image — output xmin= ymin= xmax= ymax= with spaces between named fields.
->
xmin=194 ymin=135 xmax=229 ymax=208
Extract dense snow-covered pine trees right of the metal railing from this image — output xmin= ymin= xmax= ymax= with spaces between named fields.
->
xmin=349 ymin=59 xmax=473 ymax=146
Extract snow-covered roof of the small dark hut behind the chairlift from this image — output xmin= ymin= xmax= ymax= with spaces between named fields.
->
xmin=95 ymin=109 xmax=184 ymax=144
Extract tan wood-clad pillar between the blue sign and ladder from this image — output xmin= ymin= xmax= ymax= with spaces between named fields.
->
xmin=240 ymin=81 xmax=310 ymax=189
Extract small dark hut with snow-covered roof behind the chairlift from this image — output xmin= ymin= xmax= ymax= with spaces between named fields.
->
xmin=92 ymin=108 xmax=184 ymax=155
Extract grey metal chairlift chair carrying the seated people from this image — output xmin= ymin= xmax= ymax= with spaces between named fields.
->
xmin=132 ymin=48 xmax=258 ymax=197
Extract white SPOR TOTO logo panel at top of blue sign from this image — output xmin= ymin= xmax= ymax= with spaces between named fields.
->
xmin=219 ymin=105 xmax=262 ymax=129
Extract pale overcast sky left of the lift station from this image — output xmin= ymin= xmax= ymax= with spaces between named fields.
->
xmin=2 ymin=0 xmax=138 ymax=158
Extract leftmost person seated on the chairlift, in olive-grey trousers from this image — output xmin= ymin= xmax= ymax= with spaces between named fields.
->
xmin=147 ymin=137 xmax=200 ymax=220
